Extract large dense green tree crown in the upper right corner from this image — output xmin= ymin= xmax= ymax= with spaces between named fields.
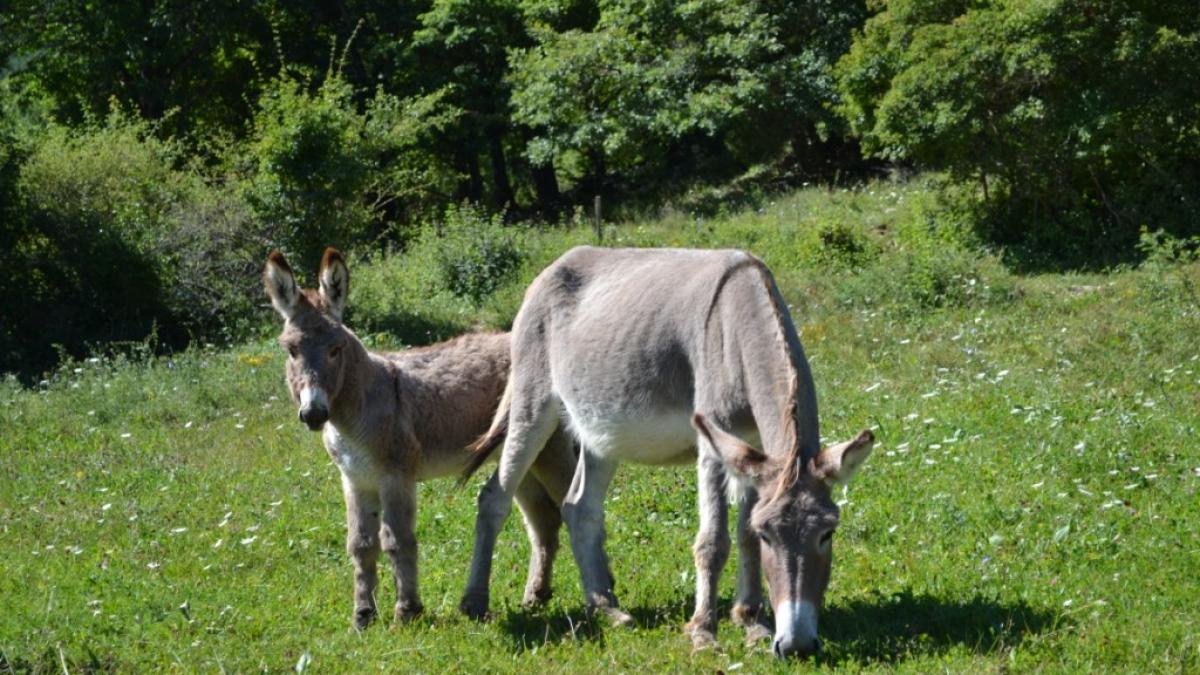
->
xmin=838 ymin=0 xmax=1200 ymax=257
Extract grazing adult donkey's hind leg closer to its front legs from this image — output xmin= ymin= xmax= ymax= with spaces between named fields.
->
xmin=563 ymin=448 xmax=634 ymax=626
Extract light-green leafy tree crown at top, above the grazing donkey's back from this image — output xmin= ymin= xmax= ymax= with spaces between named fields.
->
xmin=511 ymin=0 xmax=863 ymax=191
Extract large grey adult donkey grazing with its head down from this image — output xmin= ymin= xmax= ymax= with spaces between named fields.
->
xmin=468 ymin=247 xmax=874 ymax=658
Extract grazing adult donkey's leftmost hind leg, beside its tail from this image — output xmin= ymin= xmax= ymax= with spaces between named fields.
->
xmin=458 ymin=396 xmax=558 ymax=620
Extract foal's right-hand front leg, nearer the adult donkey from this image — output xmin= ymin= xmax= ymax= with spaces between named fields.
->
xmin=380 ymin=477 xmax=424 ymax=622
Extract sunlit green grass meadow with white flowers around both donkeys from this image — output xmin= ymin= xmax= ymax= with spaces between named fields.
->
xmin=0 ymin=185 xmax=1200 ymax=673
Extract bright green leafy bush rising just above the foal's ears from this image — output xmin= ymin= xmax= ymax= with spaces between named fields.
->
xmin=246 ymin=73 xmax=458 ymax=264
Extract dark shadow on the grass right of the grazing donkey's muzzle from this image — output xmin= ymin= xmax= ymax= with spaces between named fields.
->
xmin=820 ymin=591 xmax=1062 ymax=664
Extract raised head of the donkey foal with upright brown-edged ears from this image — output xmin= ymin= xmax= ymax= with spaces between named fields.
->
xmin=263 ymin=249 xmax=355 ymax=431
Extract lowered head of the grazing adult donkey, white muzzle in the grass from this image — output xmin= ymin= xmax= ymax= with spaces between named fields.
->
xmin=692 ymin=413 xmax=875 ymax=658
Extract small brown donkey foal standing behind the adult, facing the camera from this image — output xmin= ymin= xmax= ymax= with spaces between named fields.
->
xmin=263 ymin=249 xmax=575 ymax=629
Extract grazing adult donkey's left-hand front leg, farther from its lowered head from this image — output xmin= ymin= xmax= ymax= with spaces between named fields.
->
xmin=686 ymin=450 xmax=730 ymax=650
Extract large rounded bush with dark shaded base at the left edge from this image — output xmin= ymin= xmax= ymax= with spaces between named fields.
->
xmin=0 ymin=109 xmax=270 ymax=377
